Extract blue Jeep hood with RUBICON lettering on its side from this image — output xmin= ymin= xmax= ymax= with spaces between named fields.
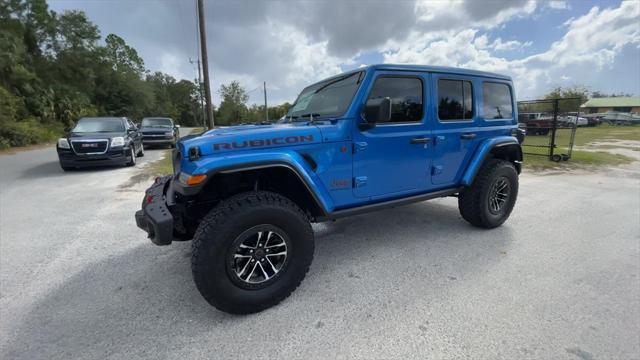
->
xmin=181 ymin=123 xmax=322 ymax=155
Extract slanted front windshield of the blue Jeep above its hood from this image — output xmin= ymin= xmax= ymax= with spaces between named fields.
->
xmin=286 ymin=71 xmax=364 ymax=121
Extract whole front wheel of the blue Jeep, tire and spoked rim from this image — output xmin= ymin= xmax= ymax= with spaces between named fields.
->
xmin=191 ymin=191 xmax=314 ymax=314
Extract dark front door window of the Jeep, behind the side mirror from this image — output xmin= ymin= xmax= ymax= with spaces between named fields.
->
xmin=368 ymin=77 xmax=423 ymax=122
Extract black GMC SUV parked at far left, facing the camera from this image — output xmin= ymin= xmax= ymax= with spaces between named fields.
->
xmin=56 ymin=117 xmax=144 ymax=171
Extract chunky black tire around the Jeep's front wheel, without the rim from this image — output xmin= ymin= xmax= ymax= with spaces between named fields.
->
xmin=191 ymin=191 xmax=314 ymax=314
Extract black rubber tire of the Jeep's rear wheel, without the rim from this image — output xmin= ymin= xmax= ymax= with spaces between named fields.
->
xmin=458 ymin=159 xmax=518 ymax=229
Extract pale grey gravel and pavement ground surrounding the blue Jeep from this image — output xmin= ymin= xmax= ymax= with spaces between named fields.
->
xmin=0 ymin=139 xmax=640 ymax=359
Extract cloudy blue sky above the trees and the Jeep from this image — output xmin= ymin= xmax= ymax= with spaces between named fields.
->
xmin=49 ymin=0 xmax=640 ymax=106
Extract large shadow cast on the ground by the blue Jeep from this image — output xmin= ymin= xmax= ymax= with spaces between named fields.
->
xmin=2 ymin=200 xmax=513 ymax=359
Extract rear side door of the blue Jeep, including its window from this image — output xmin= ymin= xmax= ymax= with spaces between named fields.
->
xmin=431 ymin=74 xmax=481 ymax=187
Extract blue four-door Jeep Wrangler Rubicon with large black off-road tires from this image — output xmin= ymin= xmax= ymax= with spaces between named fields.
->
xmin=136 ymin=65 xmax=522 ymax=313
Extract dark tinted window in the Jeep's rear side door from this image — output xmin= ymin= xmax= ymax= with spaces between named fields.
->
xmin=438 ymin=79 xmax=473 ymax=121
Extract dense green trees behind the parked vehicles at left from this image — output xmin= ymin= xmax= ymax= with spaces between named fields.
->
xmin=0 ymin=0 xmax=288 ymax=148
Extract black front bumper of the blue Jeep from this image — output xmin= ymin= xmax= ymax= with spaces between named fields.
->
xmin=135 ymin=175 xmax=174 ymax=245
